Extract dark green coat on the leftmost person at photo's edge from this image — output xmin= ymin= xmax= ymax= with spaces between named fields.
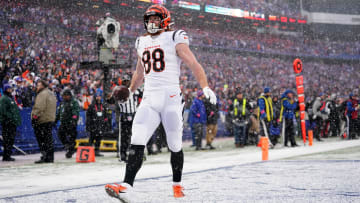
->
xmin=0 ymin=94 xmax=21 ymax=126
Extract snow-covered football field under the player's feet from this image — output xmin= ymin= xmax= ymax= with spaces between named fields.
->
xmin=0 ymin=138 xmax=360 ymax=202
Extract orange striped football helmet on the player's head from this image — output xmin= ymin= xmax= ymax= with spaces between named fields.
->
xmin=144 ymin=5 xmax=172 ymax=34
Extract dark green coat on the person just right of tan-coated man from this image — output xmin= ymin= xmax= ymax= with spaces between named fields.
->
xmin=56 ymin=98 xmax=80 ymax=127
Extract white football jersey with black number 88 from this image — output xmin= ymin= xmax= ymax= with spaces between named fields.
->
xmin=135 ymin=30 xmax=189 ymax=91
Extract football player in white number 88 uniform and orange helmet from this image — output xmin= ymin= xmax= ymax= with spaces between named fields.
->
xmin=105 ymin=5 xmax=216 ymax=202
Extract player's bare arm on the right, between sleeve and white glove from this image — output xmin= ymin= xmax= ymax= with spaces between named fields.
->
xmin=176 ymin=43 xmax=209 ymax=88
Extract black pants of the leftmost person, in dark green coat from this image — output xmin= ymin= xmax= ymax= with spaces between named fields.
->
xmin=1 ymin=123 xmax=16 ymax=159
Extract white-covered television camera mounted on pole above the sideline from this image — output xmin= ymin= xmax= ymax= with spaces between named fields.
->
xmin=80 ymin=13 xmax=131 ymax=98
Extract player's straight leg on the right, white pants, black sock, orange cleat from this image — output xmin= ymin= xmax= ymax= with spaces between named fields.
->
xmin=161 ymin=96 xmax=184 ymax=197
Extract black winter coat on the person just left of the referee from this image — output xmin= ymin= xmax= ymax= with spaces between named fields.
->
xmin=86 ymin=100 xmax=111 ymax=134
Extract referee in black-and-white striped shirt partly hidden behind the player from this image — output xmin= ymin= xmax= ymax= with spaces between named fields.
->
xmin=117 ymin=74 xmax=140 ymax=163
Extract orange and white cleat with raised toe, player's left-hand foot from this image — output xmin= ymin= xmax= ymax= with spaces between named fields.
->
xmin=105 ymin=183 xmax=132 ymax=203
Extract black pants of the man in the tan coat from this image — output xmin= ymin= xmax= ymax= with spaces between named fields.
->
xmin=34 ymin=122 xmax=54 ymax=161
